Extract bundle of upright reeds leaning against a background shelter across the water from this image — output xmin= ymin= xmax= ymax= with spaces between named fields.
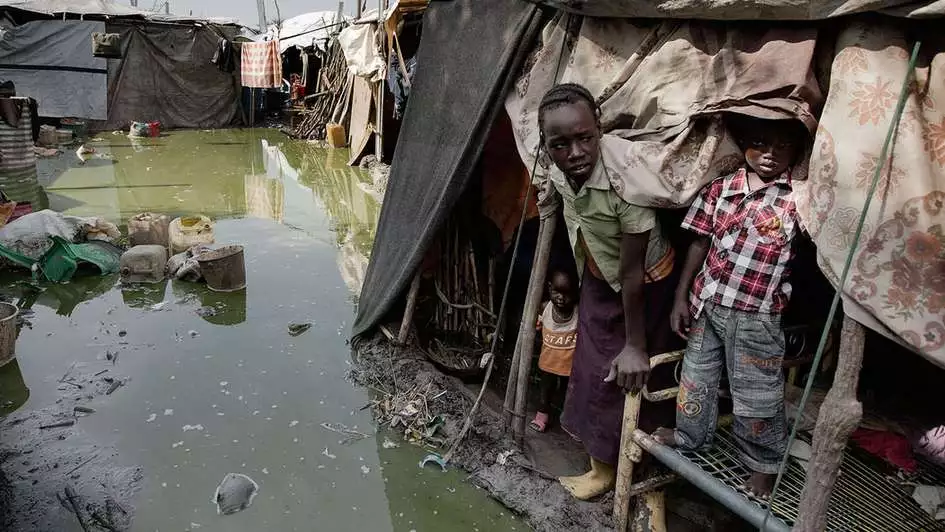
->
xmin=295 ymin=39 xmax=352 ymax=140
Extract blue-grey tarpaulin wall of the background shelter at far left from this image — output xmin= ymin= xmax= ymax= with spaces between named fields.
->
xmin=0 ymin=20 xmax=108 ymax=120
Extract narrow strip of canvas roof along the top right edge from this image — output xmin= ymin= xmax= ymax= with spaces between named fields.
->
xmin=529 ymin=0 xmax=945 ymax=20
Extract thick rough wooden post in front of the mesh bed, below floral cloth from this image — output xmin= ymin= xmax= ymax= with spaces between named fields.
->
xmin=794 ymin=316 xmax=866 ymax=532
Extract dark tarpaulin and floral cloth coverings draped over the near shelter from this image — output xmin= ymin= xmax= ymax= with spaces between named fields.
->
xmin=354 ymin=0 xmax=945 ymax=374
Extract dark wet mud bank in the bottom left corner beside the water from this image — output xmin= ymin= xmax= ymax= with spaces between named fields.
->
xmin=0 ymin=368 xmax=142 ymax=532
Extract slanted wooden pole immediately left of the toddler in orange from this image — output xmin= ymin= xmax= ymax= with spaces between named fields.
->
xmin=512 ymin=213 xmax=557 ymax=441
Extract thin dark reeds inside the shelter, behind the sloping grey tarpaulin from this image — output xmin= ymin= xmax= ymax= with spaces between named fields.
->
xmin=433 ymin=220 xmax=496 ymax=344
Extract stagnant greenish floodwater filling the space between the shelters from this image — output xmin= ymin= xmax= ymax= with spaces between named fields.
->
xmin=0 ymin=130 xmax=527 ymax=531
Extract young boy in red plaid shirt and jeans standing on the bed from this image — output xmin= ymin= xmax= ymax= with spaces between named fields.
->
xmin=656 ymin=118 xmax=803 ymax=497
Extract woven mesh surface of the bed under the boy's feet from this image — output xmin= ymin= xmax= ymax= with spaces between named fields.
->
xmin=635 ymin=427 xmax=945 ymax=532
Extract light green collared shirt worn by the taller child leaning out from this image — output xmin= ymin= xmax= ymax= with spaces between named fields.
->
xmin=550 ymin=150 xmax=672 ymax=292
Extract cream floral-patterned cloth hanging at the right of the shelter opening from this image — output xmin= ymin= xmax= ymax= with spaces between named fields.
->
xmin=795 ymin=21 xmax=945 ymax=367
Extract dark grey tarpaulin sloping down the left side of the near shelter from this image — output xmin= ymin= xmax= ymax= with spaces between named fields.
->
xmin=353 ymin=0 xmax=540 ymax=335
